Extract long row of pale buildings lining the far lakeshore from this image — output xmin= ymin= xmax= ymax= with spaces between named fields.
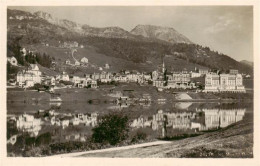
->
xmin=13 ymin=58 xmax=245 ymax=92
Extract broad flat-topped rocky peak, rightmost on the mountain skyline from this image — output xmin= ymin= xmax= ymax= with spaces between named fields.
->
xmin=131 ymin=25 xmax=192 ymax=44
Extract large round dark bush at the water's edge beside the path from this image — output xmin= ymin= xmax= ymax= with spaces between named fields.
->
xmin=92 ymin=114 xmax=129 ymax=145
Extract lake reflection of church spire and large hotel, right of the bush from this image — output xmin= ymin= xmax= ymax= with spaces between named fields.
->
xmin=130 ymin=108 xmax=246 ymax=137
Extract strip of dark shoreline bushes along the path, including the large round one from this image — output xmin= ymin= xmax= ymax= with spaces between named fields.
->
xmin=7 ymin=114 xmax=151 ymax=157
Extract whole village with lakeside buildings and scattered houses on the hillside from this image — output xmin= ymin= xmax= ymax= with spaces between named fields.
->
xmin=7 ymin=42 xmax=250 ymax=93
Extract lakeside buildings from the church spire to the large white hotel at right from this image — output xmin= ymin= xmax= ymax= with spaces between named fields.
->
xmin=152 ymin=62 xmax=246 ymax=93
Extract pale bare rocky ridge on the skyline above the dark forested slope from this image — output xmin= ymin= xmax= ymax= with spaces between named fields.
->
xmin=8 ymin=9 xmax=192 ymax=43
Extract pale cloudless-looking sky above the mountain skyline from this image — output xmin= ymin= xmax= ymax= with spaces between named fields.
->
xmin=8 ymin=6 xmax=253 ymax=61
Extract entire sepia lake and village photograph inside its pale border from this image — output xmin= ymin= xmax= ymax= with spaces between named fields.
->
xmin=2 ymin=1 xmax=259 ymax=163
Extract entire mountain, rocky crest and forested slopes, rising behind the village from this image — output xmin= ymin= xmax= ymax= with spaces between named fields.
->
xmin=7 ymin=9 xmax=253 ymax=74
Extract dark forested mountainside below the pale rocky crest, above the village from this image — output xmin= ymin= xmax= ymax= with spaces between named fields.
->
xmin=7 ymin=10 xmax=252 ymax=73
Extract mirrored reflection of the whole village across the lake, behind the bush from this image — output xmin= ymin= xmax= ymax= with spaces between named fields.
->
xmin=7 ymin=102 xmax=251 ymax=149
